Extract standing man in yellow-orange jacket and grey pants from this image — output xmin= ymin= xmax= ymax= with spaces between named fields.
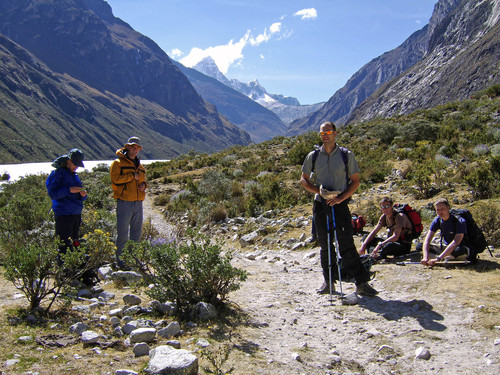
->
xmin=110 ymin=137 xmax=147 ymax=269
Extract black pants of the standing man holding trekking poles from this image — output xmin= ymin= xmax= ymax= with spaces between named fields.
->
xmin=313 ymin=201 xmax=370 ymax=284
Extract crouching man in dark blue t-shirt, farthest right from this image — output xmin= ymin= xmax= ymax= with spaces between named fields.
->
xmin=417 ymin=199 xmax=470 ymax=266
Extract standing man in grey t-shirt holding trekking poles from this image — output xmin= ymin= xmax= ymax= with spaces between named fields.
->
xmin=300 ymin=122 xmax=378 ymax=298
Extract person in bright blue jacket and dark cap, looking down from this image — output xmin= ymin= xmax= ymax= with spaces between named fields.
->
xmin=45 ymin=148 xmax=87 ymax=254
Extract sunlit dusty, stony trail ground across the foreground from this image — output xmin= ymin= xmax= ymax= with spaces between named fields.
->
xmin=0 ymin=200 xmax=500 ymax=375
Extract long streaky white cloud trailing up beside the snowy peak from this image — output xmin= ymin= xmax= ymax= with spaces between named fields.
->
xmin=179 ymin=22 xmax=282 ymax=74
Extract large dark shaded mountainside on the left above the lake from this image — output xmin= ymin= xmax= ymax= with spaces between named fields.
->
xmin=0 ymin=0 xmax=250 ymax=163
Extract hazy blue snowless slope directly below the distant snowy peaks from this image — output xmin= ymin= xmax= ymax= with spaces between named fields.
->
xmin=175 ymin=60 xmax=287 ymax=143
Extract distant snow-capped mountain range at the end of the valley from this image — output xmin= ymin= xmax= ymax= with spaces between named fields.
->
xmin=191 ymin=57 xmax=324 ymax=126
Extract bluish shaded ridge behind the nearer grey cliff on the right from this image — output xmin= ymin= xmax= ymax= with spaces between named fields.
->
xmin=289 ymin=0 xmax=462 ymax=135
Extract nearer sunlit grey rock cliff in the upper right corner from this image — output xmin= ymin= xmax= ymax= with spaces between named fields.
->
xmin=349 ymin=0 xmax=500 ymax=121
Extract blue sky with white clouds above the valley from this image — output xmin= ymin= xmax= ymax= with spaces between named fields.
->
xmin=106 ymin=0 xmax=437 ymax=104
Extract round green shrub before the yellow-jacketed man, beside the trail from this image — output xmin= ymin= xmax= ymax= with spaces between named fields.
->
xmin=123 ymin=235 xmax=247 ymax=313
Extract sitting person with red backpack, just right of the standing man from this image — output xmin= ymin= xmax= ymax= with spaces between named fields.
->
xmin=358 ymin=197 xmax=412 ymax=260
